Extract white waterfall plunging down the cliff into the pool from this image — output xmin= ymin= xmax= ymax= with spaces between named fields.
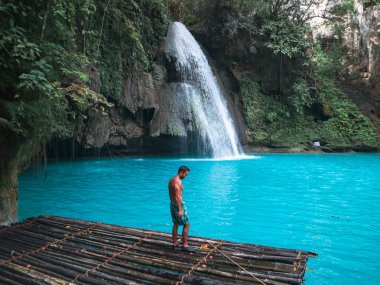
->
xmin=165 ymin=22 xmax=243 ymax=158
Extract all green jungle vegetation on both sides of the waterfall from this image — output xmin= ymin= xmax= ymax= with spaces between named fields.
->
xmin=0 ymin=0 xmax=379 ymax=181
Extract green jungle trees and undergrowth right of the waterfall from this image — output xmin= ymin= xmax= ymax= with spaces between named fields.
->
xmin=169 ymin=0 xmax=380 ymax=148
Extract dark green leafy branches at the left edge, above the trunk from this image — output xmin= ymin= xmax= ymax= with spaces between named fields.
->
xmin=0 ymin=1 xmax=58 ymax=149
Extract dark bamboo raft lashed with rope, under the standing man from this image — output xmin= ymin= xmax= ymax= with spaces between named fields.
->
xmin=0 ymin=216 xmax=317 ymax=285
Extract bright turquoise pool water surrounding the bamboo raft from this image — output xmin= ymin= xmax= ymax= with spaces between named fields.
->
xmin=19 ymin=154 xmax=380 ymax=285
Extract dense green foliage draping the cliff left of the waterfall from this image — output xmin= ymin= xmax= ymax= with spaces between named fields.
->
xmin=0 ymin=0 xmax=167 ymax=175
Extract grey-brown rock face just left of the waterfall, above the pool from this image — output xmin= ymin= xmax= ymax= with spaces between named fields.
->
xmin=77 ymin=65 xmax=165 ymax=149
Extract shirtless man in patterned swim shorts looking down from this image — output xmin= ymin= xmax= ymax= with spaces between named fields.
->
xmin=169 ymin=166 xmax=195 ymax=252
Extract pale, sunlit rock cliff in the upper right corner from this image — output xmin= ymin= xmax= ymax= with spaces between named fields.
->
xmin=309 ymin=0 xmax=380 ymax=137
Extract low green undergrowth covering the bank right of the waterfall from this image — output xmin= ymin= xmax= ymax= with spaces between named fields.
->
xmin=240 ymin=70 xmax=377 ymax=147
